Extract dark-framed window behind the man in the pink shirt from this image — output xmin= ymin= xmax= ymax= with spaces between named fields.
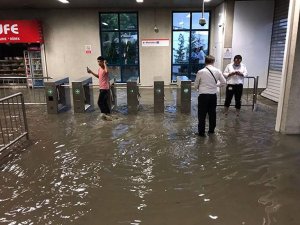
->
xmin=100 ymin=13 xmax=139 ymax=82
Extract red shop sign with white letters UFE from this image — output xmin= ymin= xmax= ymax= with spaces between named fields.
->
xmin=0 ymin=20 xmax=44 ymax=43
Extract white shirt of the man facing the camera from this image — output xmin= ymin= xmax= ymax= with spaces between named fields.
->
xmin=223 ymin=63 xmax=248 ymax=84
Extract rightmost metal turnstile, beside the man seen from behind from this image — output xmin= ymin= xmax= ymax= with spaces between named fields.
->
xmin=176 ymin=76 xmax=192 ymax=113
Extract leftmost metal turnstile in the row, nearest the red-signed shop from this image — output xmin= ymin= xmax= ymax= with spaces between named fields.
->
xmin=44 ymin=77 xmax=71 ymax=114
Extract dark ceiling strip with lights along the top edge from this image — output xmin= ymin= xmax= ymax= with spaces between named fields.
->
xmin=0 ymin=0 xmax=224 ymax=9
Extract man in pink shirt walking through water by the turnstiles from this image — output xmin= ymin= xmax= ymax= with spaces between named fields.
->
xmin=87 ymin=56 xmax=112 ymax=120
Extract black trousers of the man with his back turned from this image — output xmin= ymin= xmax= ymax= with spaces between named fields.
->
xmin=198 ymin=94 xmax=217 ymax=134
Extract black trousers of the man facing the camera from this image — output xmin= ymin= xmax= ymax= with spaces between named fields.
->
xmin=224 ymin=84 xmax=243 ymax=109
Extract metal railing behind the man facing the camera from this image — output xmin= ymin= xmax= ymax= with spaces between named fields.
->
xmin=217 ymin=76 xmax=258 ymax=111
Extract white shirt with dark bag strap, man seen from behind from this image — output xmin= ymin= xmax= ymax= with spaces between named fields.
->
xmin=194 ymin=65 xmax=226 ymax=94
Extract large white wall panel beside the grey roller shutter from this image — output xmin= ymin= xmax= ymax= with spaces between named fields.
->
xmin=232 ymin=1 xmax=274 ymax=88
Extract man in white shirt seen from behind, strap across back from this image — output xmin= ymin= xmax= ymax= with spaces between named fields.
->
xmin=194 ymin=55 xmax=226 ymax=137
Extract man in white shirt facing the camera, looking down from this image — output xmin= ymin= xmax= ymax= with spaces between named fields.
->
xmin=223 ymin=55 xmax=248 ymax=116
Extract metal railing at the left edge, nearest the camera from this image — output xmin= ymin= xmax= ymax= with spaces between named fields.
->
xmin=0 ymin=93 xmax=29 ymax=154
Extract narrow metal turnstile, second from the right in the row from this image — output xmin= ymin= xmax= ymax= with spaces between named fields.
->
xmin=154 ymin=77 xmax=165 ymax=113
